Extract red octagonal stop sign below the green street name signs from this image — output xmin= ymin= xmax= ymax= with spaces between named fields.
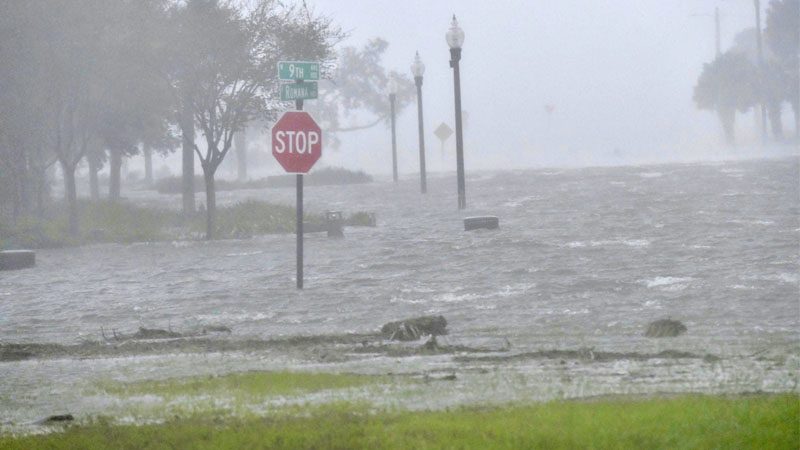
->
xmin=272 ymin=111 xmax=322 ymax=173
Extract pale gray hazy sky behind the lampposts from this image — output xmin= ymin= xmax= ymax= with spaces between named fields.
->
xmin=300 ymin=0 xmax=768 ymax=172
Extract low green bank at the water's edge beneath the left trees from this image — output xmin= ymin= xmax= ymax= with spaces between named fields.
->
xmin=0 ymin=200 xmax=376 ymax=250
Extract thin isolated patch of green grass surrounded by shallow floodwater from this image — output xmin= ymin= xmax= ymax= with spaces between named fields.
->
xmin=101 ymin=372 xmax=384 ymax=398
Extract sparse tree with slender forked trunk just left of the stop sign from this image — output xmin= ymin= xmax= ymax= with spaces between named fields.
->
xmin=172 ymin=0 xmax=341 ymax=239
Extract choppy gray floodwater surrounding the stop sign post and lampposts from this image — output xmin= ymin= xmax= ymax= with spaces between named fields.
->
xmin=0 ymin=158 xmax=800 ymax=429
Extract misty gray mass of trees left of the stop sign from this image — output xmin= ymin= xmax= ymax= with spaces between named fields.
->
xmin=0 ymin=0 xmax=354 ymax=238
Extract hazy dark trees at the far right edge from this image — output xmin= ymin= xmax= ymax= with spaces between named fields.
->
xmin=694 ymin=0 xmax=800 ymax=144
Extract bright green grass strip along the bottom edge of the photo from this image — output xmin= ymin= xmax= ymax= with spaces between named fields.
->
xmin=0 ymin=394 xmax=800 ymax=449
